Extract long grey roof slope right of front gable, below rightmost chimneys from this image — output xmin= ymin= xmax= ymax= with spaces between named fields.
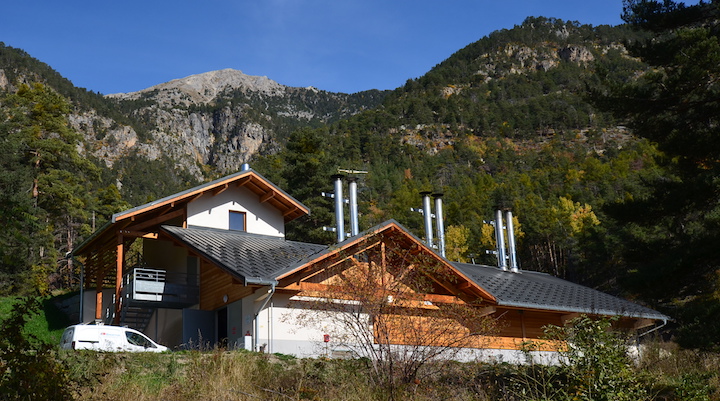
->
xmin=452 ymin=262 xmax=670 ymax=321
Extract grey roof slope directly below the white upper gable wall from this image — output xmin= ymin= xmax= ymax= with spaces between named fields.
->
xmin=162 ymin=226 xmax=327 ymax=282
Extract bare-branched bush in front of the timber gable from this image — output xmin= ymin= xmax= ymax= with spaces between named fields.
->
xmin=284 ymin=234 xmax=495 ymax=393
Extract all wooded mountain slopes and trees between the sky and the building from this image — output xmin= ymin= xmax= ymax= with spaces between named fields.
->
xmin=0 ymin=1 xmax=720 ymax=348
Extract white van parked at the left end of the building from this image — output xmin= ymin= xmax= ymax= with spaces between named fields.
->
xmin=60 ymin=324 xmax=167 ymax=352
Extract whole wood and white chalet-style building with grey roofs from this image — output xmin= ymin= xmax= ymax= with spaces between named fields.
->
xmin=73 ymin=169 xmax=669 ymax=356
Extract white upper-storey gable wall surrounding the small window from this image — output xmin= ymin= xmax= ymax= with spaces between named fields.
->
xmin=187 ymin=187 xmax=285 ymax=237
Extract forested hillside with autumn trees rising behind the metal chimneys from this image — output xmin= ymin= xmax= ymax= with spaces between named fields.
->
xmin=256 ymin=18 xmax=658 ymax=284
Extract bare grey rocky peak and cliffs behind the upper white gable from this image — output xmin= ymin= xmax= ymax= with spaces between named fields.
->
xmin=70 ymin=69 xmax=382 ymax=180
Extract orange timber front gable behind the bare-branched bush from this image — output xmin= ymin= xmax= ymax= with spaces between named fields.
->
xmin=278 ymin=223 xmax=506 ymax=347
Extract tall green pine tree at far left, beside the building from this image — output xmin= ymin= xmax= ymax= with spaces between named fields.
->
xmin=0 ymin=84 xmax=97 ymax=292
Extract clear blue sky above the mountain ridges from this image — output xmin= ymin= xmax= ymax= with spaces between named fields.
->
xmin=0 ymin=0 xmax=695 ymax=94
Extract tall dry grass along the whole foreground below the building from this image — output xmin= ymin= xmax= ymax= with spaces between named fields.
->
xmin=57 ymin=344 xmax=720 ymax=401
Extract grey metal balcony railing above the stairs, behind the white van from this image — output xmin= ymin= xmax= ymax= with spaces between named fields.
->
xmin=123 ymin=268 xmax=200 ymax=308
